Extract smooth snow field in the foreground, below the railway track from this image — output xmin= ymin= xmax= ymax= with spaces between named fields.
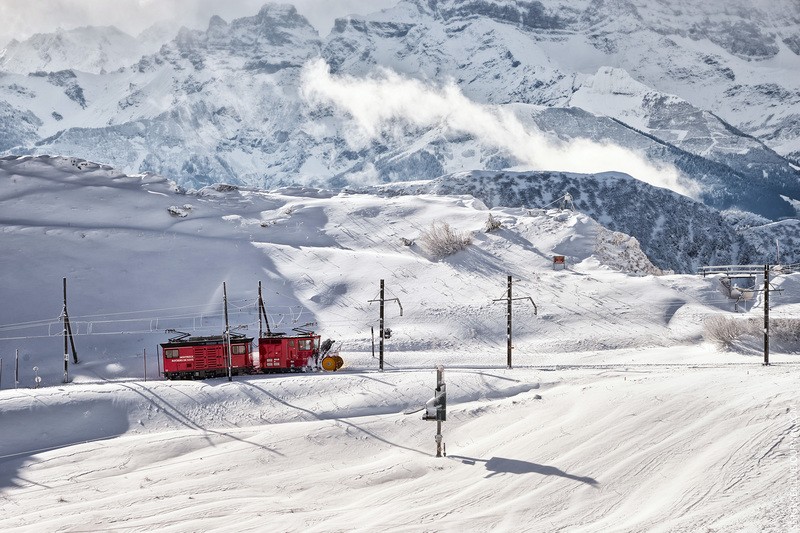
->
xmin=0 ymin=360 xmax=798 ymax=531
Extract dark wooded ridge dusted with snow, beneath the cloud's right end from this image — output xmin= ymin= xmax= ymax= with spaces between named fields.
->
xmin=365 ymin=171 xmax=780 ymax=273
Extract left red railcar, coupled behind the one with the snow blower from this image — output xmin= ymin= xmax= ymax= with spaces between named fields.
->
xmin=161 ymin=333 xmax=253 ymax=379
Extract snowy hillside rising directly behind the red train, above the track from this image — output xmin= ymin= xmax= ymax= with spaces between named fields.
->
xmin=0 ymin=154 xmax=703 ymax=383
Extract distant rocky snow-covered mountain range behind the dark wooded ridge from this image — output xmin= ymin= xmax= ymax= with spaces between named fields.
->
xmin=0 ymin=1 xmax=800 ymax=206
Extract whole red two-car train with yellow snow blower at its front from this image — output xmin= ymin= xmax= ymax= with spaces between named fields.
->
xmin=161 ymin=283 xmax=343 ymax=379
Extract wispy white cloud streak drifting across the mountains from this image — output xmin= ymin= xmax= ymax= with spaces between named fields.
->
xmin=301 ymin=60 xmax=695 ymax=196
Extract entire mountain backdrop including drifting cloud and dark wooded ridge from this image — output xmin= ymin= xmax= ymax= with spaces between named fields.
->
xmin=0 ymin=0 xmax=800 ymax=278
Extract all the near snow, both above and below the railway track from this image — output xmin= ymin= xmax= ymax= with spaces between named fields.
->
xmin=0 ymin=158 xmax=800 ymax=531
